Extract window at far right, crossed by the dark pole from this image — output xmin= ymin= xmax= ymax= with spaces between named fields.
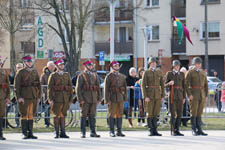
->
xmin=200 ymin=22 xmax=220 ymax=39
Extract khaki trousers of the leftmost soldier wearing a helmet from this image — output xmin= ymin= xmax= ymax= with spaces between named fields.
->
xmin=144 ymin=99 xmax=162 ymax=118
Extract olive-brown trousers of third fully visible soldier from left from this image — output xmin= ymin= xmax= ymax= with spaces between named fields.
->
xmin=80 ymin=102 xmax=97 ymax=118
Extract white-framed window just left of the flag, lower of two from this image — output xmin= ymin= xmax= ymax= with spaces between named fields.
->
xmin=146 ymin=25 xmax=159 ymax=41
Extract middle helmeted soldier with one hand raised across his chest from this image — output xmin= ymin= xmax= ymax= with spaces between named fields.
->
xmin=165 ymin=60 xmax=186 ymax=136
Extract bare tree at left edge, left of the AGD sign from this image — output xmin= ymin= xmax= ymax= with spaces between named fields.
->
xmin=0 ymin=0 xmax=26 ymax=74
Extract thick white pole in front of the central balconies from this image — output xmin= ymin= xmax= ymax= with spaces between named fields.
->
xmin=109 ymin=0 xmax=116 ymax=62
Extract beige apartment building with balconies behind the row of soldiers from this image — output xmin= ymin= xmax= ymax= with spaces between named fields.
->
xmin=0 ymin=0 xmax=225 ymax=79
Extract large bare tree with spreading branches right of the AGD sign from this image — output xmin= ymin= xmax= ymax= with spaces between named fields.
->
xmin=34 ymin=0 xmax=101 ymax=75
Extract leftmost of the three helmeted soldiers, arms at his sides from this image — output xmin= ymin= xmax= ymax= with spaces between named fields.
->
xmin=141 ymin=57 xmax=165 ymax=136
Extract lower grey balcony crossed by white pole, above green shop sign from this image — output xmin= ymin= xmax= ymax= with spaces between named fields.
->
xmin=95 ymin=41 xmax=133 ymax=54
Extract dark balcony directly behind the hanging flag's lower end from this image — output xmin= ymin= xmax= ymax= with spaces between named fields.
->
xmin=171 ymin=39 xmax=186 ymax=54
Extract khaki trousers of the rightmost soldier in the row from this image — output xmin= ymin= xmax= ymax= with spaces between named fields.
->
xmin=189 ymin=97 xmax=205 ymax=117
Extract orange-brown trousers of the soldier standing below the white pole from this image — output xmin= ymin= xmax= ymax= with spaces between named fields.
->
xmin=108 ymin=102 xmax=124 ymax=118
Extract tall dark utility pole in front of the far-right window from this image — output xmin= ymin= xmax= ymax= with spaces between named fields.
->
xmin=205 ymin=0 xmax=209 ymax=73
